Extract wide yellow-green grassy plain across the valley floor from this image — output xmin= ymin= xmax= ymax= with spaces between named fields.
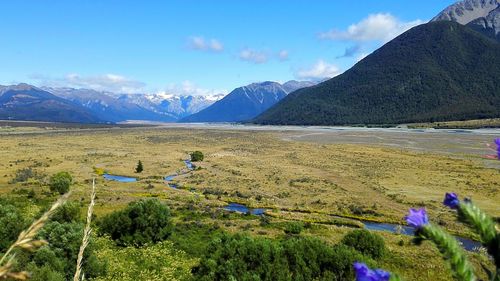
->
xmin=0 ymin=127 xmax=500 ymax=280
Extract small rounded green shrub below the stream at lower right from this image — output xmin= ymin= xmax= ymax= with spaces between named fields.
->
xmin=342 ymin=229 xmax=385 ymax=259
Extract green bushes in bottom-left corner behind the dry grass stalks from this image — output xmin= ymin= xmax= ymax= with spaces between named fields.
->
xmin=0 ymin=197 xmax=106 ymax=281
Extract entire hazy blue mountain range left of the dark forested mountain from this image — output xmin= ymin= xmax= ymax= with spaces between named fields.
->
xmin=0 ymin=81 xmax=314 ymax=123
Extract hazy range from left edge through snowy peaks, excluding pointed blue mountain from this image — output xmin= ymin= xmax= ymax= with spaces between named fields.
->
xmin=0 ymin=83 xmax=224 ymax=123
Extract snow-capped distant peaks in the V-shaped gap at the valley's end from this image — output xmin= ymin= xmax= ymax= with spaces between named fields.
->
xmin=115 ymin=93 xmax=224 ymax=120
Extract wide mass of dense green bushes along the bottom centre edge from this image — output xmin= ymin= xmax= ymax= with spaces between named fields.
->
xmin=194 ymin=231 xmax=382 ymax=280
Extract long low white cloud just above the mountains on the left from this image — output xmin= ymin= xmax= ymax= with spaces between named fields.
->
xmin=30 ymin=73 xmax=146 ymax=93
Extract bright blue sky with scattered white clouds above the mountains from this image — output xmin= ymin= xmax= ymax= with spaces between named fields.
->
xmin=0 ymin=0 xmax=454 ymax=94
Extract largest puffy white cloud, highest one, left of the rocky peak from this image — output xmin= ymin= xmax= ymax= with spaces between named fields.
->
xmin=319 ymin=13 xmax=424 ymax=42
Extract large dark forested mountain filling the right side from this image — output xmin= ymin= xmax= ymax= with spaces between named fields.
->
xmin=254 ymin=21 xmax=500 ymax=125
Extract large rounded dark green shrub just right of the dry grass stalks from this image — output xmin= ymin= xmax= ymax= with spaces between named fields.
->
xmin=99 ymin=199 xmax=172 ymax=246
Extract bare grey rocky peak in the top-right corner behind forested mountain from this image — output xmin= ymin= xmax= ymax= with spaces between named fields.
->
xmin=432 ymin=0 xmax=500 ymax=41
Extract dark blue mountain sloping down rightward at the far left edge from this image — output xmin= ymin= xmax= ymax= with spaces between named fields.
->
xmin=0 ymin=84 xmax=105 ymax=123
